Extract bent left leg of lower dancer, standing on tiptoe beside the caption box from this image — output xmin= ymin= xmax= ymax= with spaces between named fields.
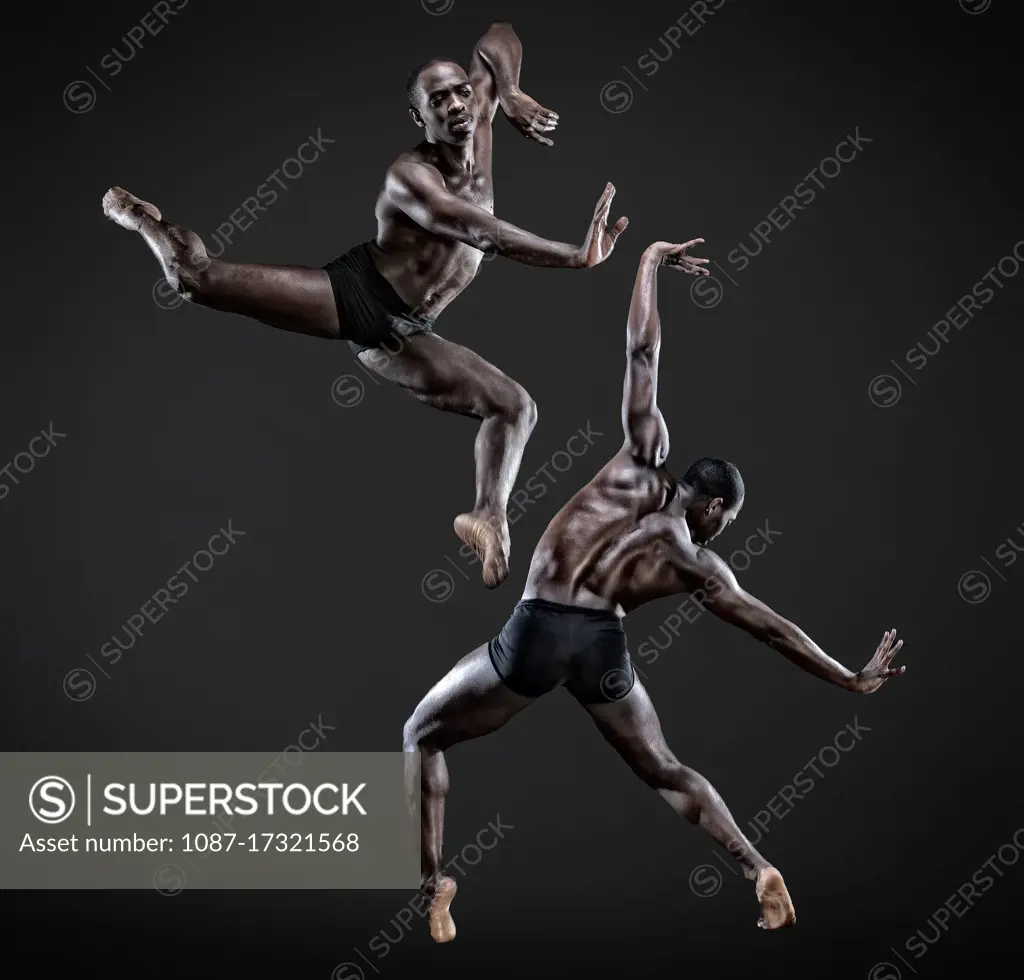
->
xmin=403 ymin=644 xmax=534 ymax=942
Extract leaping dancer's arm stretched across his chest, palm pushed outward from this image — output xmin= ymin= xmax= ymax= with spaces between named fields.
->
xmin=386 ymin=161 xmax=629 ymax=268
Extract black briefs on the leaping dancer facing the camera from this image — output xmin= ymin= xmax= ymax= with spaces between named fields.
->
xmin=324 ymin=242 xmax=434 ymax=353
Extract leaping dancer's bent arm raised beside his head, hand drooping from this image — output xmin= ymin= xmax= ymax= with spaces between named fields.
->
xmin=469 ymin=22 xmax=558 ymax=146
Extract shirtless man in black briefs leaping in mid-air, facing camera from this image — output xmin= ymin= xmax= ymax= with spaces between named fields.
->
xmin=103 ymin=24 xmax=629 ymax=588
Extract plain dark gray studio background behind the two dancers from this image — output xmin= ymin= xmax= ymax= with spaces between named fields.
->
xmin=0 ymin=0 xmax=1024 ymax=980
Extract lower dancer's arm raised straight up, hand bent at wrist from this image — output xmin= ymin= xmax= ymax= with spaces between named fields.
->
xmin=623 ymin=239 xmax=708 ymax=467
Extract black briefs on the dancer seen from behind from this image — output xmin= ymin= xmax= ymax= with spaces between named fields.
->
xmin=487 ymin=599 xmax=635 ymax=705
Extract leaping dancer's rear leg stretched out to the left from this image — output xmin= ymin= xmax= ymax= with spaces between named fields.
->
xmin=103 ymin=187 xmax=341 ymax=338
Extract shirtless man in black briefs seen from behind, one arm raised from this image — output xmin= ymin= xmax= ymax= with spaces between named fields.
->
xmin=404 ymin=239 xmax=905 ymax=942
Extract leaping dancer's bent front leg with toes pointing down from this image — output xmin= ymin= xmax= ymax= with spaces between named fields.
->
xmin=359 ymin=334 xmax=537 ymax=589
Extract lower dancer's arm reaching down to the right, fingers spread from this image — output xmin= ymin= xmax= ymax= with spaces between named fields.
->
xmin=681 ymin=548 xmax=906 ymax=694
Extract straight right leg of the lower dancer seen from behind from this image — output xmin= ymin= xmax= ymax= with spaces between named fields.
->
xmin=586 ymin=678 xmax=796 ymax=929
